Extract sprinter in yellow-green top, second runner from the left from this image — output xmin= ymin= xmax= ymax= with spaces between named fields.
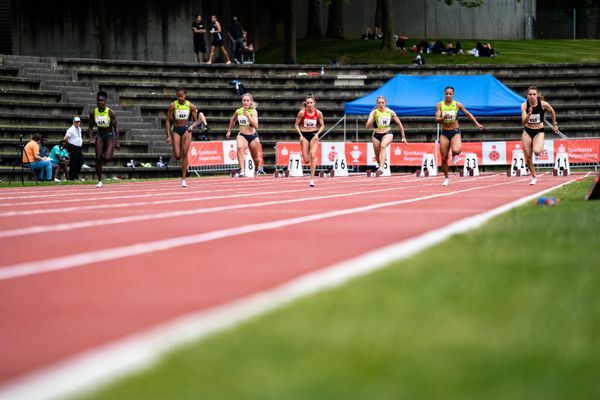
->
xmin=165 ymin=87 xmax=198 ymax=187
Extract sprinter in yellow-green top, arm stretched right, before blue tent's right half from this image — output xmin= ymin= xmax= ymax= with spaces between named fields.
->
xmin=435 ymin=86 xmax=483 ymax=186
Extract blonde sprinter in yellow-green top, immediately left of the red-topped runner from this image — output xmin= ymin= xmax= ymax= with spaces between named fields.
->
xmin=225 ymin=93 xmax=261 ymax=177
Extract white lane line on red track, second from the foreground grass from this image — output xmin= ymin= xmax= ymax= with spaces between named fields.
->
xmin=0 ymin=177 xmax=512 ymax=281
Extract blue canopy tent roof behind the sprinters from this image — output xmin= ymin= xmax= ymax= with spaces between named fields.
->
xmin=344 ymin=75 xmax=525 ymax=118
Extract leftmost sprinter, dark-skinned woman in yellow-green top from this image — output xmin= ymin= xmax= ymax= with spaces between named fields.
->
xmin=88 ymin=90 xmax=120 ymax=188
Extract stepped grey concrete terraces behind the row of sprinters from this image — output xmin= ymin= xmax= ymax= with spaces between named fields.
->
xmin=0 ymin=56 xmax=600 ymax=179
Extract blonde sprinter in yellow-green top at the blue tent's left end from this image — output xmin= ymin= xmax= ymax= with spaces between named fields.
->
xmin=366 ymin=96 xmax=407 ymax=176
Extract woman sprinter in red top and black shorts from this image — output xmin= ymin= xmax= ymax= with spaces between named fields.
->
xmin=294 ymin=94 xmax=325 ymax=187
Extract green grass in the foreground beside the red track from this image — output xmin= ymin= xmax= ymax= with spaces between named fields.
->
xmin=76 ymin=178 xmax=600 ymax=399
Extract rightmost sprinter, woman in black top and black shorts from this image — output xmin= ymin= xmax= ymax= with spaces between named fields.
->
xmin=521 ymin=86 xmax=558 ymax=185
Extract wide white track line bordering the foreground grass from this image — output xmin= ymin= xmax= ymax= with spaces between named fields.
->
xmin=0 ymin=180 xmax=574 ymax=400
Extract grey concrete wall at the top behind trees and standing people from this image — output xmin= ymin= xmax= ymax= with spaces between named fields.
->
xmin=12 ymin=0 xmax=535 ymax=62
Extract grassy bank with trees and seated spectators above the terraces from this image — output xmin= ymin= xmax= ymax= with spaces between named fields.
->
xmin=256 ymin=39 xmax=600 ymax=65
